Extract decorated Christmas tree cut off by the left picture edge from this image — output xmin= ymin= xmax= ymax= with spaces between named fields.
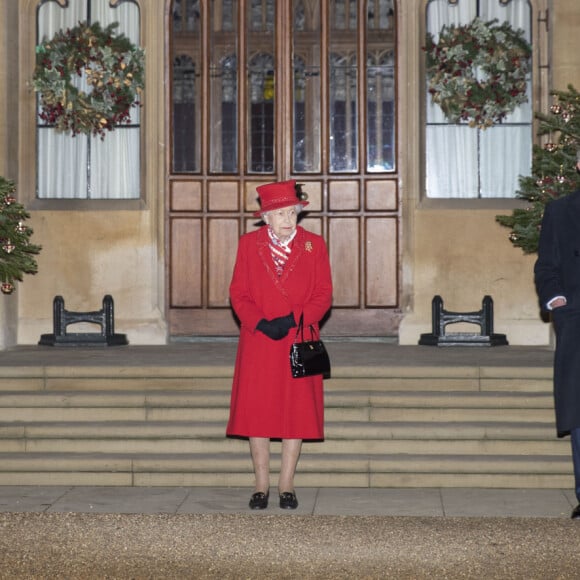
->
xmin=0 ymin=177 xmax=41 ymax=294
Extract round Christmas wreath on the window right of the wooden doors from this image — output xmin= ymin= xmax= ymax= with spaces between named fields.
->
xmin=425 ymin=18 xmax=532 ymax=129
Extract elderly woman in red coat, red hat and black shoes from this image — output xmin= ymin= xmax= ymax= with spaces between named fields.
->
xmin=227 ymin=180 xmax=332 ymax=509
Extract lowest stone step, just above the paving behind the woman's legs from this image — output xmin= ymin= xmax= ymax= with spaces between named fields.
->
xmin=0 ymin=450 xmax=573 ymax=488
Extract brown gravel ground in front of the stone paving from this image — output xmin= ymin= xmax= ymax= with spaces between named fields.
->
xmin=0 ymin=513 xmax=580 ymax=580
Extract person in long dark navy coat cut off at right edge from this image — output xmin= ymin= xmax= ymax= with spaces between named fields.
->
xmin=534 ymin=156 xmax=580 ymax=519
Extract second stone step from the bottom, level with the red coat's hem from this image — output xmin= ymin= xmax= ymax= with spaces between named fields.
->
xmin=0 ymin=421 xmax=569 ymax=454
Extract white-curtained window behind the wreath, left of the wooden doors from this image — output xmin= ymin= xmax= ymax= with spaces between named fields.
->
xmin=36 ymin=0 xmax=141 ymax=199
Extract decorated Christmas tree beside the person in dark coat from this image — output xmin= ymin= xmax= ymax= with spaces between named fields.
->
xmin=496 ymin=85 xmax=580 ymax=254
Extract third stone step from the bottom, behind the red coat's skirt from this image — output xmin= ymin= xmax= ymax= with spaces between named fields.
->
xmin=0 ymin=390 xmax=553 ymax=422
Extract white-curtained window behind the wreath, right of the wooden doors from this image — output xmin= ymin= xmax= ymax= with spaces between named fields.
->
xmin=425 ymin=0 xmax=533 ymax=199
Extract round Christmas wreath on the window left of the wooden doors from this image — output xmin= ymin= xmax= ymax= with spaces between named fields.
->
xmin=33 ymin=22 xmax=144 ymax=137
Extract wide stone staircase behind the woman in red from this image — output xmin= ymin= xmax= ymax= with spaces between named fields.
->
xmin=0 ymin=358 xmax=573 ymax=488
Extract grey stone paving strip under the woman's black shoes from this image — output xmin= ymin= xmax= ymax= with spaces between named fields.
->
xmin=0 ymin=486 xmax=576 ymax=519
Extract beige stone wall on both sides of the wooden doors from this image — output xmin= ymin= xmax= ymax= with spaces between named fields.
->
xmin=0 ymin=0 xmax=580 ymax=348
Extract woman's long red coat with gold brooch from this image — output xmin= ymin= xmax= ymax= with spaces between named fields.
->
xmin=226 ymin=226 xmax=332 ymax=439
